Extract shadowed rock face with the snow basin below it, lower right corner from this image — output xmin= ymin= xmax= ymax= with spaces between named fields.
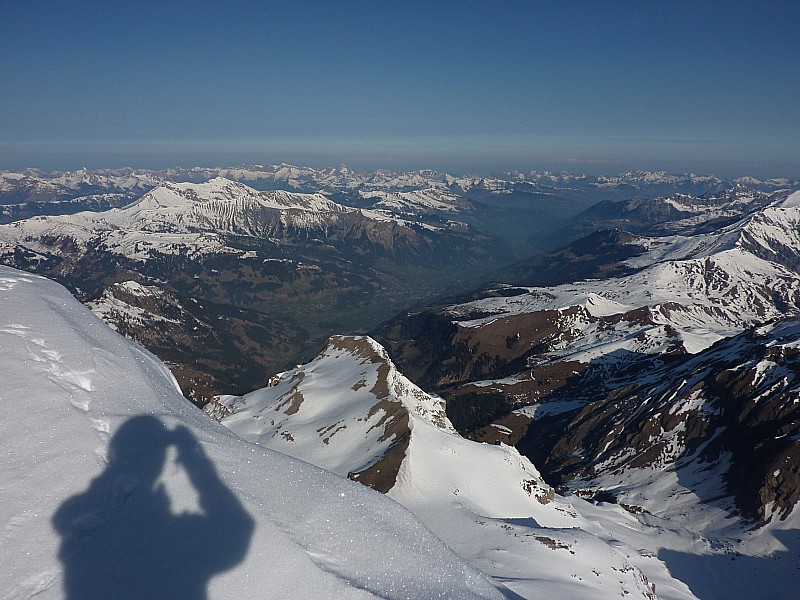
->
xmin=529 ymin=317 xmax=800 ymax=600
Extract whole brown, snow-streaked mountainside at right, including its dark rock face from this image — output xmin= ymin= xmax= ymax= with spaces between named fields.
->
xmin=374 ymin=192 xmax=800 ymax=544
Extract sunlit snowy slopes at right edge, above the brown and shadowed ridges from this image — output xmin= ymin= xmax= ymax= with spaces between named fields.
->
xmin=449 ymin=192 xmax=800 ymax=362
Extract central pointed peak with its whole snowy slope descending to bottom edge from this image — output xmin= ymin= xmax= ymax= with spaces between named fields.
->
xmin=207 ymin=337 xmax=693 ymax=600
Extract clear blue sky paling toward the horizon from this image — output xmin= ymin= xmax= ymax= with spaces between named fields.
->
xmin=0 ymin=0 xmax=800 ymax=177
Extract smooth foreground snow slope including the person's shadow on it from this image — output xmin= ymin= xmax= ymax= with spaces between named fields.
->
xmin=0 ymin=267 xmax=502 ymax=599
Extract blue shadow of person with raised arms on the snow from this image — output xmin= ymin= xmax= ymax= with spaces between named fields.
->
xmin=53 ymin=416 xmax=254 ymax=600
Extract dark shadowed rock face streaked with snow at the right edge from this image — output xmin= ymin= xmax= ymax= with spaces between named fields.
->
xmin=519 ymin=319 xmax=800 ymax=522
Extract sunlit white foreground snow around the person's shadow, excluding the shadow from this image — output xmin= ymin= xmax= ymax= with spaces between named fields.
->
xmin=0 ymin=268 xmax=502 ymax=599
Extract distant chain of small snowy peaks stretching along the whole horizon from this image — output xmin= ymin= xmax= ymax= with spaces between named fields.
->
xmin=0 ymin=164 xmax=800 ymax=223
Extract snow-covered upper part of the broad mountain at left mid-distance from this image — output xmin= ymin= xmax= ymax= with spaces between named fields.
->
xmin=2 ymin=178 xmax=468 ymax=260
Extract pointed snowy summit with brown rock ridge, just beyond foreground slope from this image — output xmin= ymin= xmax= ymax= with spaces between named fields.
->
xmin=207 ymin=336 xmax=455 ymax=492
